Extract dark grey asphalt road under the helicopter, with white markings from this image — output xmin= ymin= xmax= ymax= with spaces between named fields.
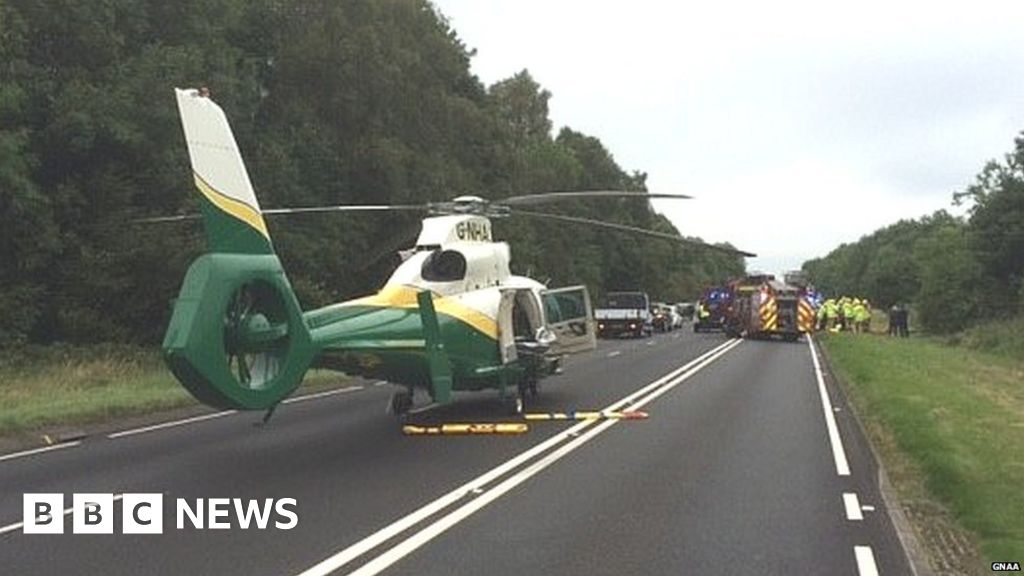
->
xmin=0 ymin=331 xmax=909 ymax=575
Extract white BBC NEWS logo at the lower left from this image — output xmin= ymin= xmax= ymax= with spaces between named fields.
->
xmin=22 ymin=493 xmax=299 ymax=534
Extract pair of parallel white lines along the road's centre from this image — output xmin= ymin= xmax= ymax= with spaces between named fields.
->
xmin=299 ymin=339 xmax=742 ymax=576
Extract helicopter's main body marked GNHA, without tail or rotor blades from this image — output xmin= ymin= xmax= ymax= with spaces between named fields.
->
xmin=296 ymin=215 xmax=590 ymax=400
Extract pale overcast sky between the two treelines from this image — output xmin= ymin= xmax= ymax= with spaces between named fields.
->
xmin=435 ymin=0 xmax=1024 ymax=273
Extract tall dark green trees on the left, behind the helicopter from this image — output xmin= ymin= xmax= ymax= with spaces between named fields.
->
xmin=0 ymin=0 xmax=742 ymax=344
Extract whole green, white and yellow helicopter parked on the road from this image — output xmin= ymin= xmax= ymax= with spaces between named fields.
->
xmin=157 ymin=88 xmax=753 ymax=418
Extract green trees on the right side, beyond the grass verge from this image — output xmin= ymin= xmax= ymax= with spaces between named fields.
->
xmin=804 ymin=133 xmax=1024 ymax=333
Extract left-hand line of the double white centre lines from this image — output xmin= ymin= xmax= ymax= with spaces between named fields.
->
xmin=300 ymin=340 xmax=741 ymax=576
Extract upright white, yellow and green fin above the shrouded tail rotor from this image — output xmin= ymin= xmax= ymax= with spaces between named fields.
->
xmin=174 ymin=88 xmax=273 ymax=254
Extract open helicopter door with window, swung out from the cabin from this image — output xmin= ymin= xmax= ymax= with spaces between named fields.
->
xmin=541 ymin=286 xmax=597 ymax=354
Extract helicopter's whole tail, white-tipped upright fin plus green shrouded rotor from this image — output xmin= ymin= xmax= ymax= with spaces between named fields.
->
xmin=163 ymin=90 xmax=316 ymax=410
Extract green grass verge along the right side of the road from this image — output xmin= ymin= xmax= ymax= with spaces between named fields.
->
xmin=820 ymin=334 xmax=1024 ymax=573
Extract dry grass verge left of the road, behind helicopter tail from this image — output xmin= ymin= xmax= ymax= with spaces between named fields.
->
xmin=0 ymin=345 xmax=352 ymax=437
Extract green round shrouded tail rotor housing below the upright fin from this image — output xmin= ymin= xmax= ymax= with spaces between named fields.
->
xmin=163 ymin=253 xmax=315 ymax=410
